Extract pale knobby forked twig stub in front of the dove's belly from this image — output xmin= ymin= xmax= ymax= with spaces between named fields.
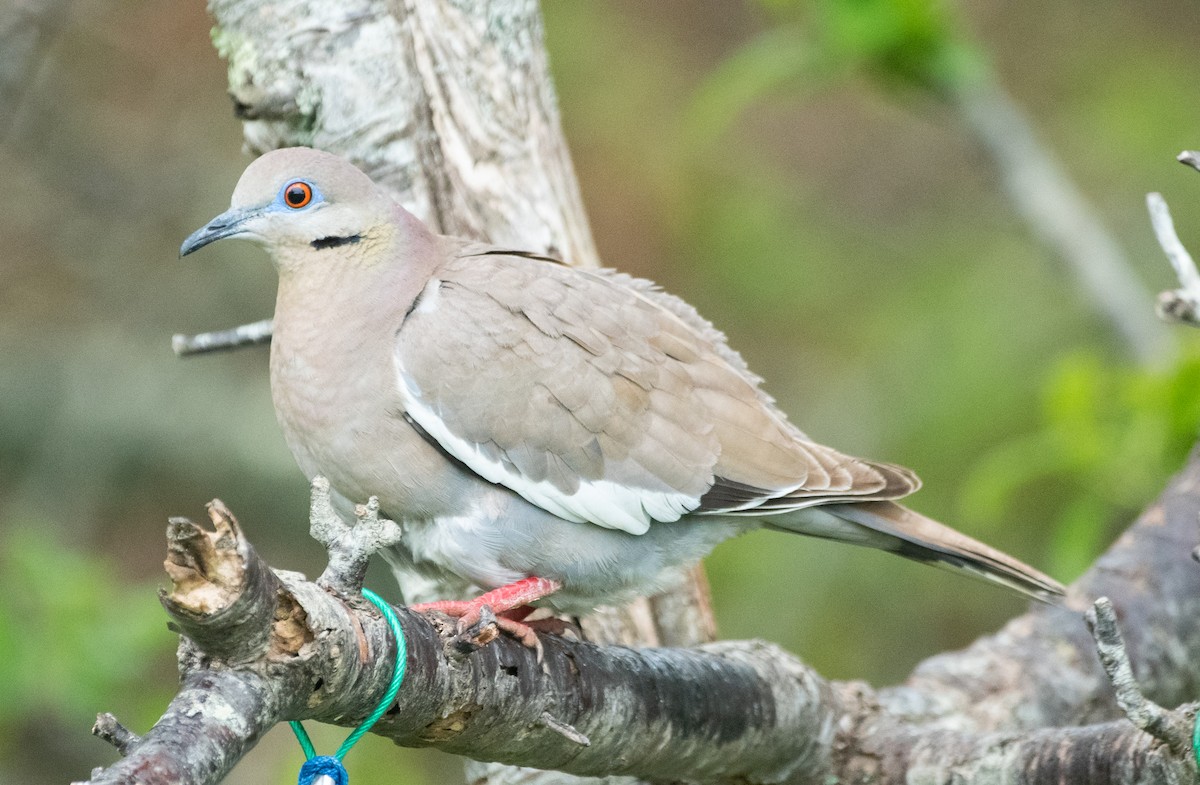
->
xmin=308 ymin=475 xmax=403 ymax=595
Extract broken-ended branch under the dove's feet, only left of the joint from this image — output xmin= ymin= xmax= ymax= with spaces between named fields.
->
xmin=79 ymin=489 xmax=835 ymax=785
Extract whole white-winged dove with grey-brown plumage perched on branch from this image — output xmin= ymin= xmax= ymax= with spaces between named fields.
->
xmin=180 ymin=148 xmax=1063 ymax=640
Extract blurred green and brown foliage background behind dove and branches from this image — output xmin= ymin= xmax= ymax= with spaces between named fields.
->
xmin=0 ymin=0 xmax=1200 ymax=785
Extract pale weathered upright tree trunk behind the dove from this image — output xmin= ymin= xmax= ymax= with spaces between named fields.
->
xmin=209 ymin=0 xmax=715 ymax=784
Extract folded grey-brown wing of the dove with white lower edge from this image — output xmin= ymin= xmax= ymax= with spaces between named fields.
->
xmin=394 ymin=251 xmax=917 ymax=534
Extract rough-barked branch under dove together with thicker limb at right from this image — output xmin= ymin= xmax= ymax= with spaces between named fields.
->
xmin=77 ymin=455 xmax=1200 ymax=785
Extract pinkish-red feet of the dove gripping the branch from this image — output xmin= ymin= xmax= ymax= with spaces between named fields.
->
xmin=412 ymin=576 xmax=563 ymax=661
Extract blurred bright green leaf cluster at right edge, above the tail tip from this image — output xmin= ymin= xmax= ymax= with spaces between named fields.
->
xmin=962 ymin=348 xmax=1200 ymax=577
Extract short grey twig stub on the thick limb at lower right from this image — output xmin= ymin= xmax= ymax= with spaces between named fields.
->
xmin=1084 ymin=597 xmax=1192 ymax=755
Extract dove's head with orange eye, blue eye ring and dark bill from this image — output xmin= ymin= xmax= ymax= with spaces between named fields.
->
xmin=179 ymin=148 xmax=424 ymax=271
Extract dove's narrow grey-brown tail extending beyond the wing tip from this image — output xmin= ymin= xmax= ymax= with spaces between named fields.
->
xmin=770 ymin=502 xmax=1066 ymax=604
